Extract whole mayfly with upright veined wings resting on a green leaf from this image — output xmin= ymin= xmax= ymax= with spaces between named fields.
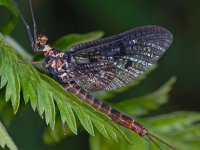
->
xmin=13 ymin=0 xmax=175 ymax=150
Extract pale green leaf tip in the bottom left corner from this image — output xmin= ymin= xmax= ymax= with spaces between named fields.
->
xmin=0 ymin=122 xmax=18 ymax=150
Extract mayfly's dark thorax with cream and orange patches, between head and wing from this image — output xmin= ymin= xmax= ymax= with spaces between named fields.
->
xmin=45 ymin=48 xmax=74 ymax=83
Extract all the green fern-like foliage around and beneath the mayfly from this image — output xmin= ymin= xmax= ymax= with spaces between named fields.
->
xmin=0 ymin=0 xmax=200 ymax=150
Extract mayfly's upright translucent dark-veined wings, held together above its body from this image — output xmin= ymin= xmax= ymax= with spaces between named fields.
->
xmin=69 ymin=26 xmax=173 ymax=91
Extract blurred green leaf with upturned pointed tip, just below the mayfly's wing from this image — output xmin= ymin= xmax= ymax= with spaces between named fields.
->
xmin=114 ymin=77 xmax=176 ymax=116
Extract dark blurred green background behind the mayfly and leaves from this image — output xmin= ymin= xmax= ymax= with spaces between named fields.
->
xmin=0 ymin=0 xmax=200 ymax=150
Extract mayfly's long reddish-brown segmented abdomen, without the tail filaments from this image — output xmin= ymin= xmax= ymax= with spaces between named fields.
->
xmin=63 ymin=83 xmax=148 ymax=136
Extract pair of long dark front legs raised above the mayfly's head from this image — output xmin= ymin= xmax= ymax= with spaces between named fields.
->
xmin=13 ymin=0 xmax=38 ymax=51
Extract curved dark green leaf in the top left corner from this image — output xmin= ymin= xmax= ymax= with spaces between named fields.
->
xmin=0 ymin=0 xmax=18 ymax=35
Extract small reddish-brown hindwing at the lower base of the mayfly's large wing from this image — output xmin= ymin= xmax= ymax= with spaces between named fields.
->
xmin=74 ymin=62 xmax=117 ymax=92
